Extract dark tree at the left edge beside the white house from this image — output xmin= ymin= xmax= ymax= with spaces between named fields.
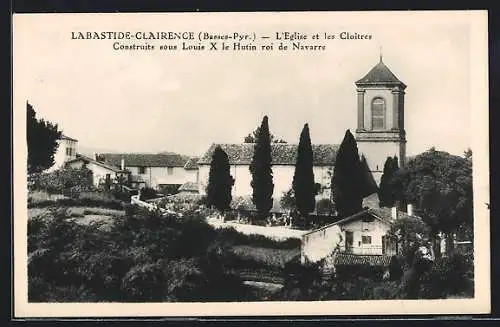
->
xmin=26 ymin=102 xmax=62 ymax=174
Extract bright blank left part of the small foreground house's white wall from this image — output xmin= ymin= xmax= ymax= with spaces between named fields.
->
xmin=300 ymin=225 xmax=343 ymax=263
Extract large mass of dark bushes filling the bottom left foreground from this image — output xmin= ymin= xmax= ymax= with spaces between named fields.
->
xmin=28 ymin=207 xmax=254 ymax=302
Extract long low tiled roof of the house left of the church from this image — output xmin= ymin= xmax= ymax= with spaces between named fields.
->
xmin=100 ymin=153 xmax=187 ymax=167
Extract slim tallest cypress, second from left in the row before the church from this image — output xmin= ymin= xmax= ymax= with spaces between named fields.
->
xmin=250 ymin=116 xmax=274 ymax=220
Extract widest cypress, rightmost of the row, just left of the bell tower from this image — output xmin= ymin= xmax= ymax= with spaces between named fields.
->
xmin=331 ymin=130 xmax=375 ymax=217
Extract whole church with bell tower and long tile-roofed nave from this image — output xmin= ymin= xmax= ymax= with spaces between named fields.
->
xmin=198 ymin=56 xmax=406 ymax=199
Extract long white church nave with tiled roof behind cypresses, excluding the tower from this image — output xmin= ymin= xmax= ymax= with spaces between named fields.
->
xmin=198 ymin=143 xmax=338 ymax=198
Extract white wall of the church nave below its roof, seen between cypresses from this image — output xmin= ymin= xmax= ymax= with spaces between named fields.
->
xmin=199 ymin=165 xmax=330 ymax=198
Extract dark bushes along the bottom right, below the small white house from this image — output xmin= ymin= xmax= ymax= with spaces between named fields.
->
xmin=273 ymin=253 xmax=474 ymax=301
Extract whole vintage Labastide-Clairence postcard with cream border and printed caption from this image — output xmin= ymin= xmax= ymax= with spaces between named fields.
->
xmin=12 ymin=11 xmax=490 ymax=317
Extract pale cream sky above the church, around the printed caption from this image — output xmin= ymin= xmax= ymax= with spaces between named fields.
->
xmin=14 ymin=13 xmax=484 ymax=155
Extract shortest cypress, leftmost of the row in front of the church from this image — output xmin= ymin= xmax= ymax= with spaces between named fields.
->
xmin=207 ymin=146 xmax=234 ymax=212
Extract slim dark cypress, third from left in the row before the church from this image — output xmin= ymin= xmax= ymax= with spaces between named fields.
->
xmin=292 ymin=124 xmax=317 ymax=228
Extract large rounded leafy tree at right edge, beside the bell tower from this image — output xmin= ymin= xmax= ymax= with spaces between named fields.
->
xmin=394 ymin=148 xmax=473 ymax=234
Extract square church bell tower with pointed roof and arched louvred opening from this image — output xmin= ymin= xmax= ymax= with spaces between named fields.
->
xmin=355 ymin=55 xmax=406 ymax=184
